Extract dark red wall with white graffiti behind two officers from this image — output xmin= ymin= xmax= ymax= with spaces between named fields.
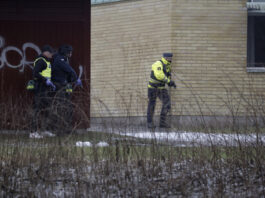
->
xmin=0 ymin=0 xmax=90 ymax=128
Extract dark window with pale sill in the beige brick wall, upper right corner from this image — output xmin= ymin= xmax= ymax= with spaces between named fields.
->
xmin=247 ymin=0 xmax=265 ymax=72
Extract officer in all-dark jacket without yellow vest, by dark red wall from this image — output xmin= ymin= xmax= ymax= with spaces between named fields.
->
xmin=52 ymin=44 xmax=82 ymax=133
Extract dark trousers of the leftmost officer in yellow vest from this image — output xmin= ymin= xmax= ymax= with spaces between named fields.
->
xmin=32 ymin=82 xmax=52 ymax=131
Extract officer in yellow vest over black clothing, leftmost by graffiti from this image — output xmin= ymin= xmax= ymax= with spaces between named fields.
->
xmin=32 ymin=45 xmax=55 ymax=134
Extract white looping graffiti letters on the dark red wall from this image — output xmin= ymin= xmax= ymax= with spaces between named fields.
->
xmin=0 ymin=36 xmax=83 ymax=77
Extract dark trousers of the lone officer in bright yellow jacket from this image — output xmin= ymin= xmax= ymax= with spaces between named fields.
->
xmin=147 ymin=88 xmax=171 ymax=125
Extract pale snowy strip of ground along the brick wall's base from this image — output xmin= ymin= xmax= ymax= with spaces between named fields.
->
xmin=87 ymin=125 xmax=265 ymax=146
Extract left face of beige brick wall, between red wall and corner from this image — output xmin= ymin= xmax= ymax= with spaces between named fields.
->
xmin=91 ymin=0 xmax=171 ymax=117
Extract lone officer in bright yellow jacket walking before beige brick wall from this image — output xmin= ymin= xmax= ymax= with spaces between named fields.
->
xmin=147 ymin=53 xmax=176 ymax=128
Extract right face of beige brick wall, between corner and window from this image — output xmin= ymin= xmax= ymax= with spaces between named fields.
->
xmin=172 ymin=0 xmax=264 ymax=115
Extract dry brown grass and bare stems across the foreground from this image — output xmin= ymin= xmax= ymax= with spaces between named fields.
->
xmin=0 ymin=83 xmax=265 ymax=197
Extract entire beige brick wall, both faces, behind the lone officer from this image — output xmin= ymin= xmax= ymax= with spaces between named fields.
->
xmin=91 ymin=0 xmax=265 ymax=117
